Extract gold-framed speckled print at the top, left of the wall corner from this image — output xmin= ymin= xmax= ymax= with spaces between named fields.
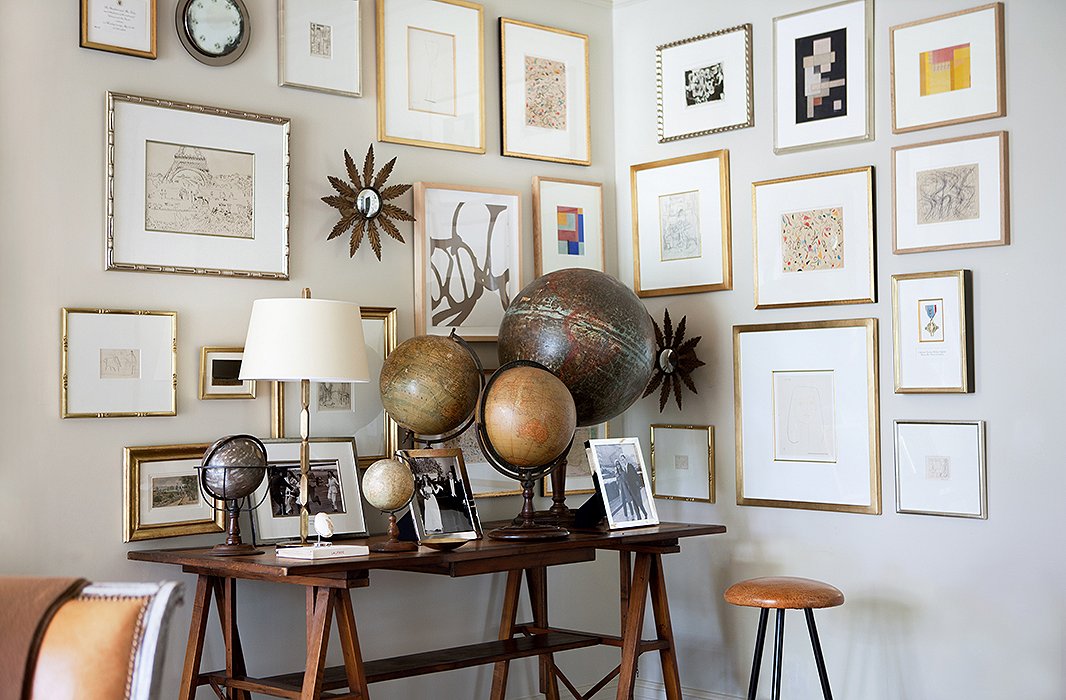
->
xmin=500 ymin=17 xmax=592 ymax=165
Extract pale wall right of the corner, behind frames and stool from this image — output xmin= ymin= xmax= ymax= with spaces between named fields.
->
xmin=614 ymin=0 xmax=1066 ymax=700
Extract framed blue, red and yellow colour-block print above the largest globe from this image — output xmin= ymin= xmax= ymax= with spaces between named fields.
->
xmin=533 ymin=176 xmax=607 ymax=277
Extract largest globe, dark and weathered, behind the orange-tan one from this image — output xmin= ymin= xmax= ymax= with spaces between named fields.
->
xmin=498 ymin=268 xmax=656 ymax=425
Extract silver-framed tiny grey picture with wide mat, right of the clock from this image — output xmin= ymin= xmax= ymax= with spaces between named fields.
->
xmin=277 ymin=0 xmax=362 ymax=97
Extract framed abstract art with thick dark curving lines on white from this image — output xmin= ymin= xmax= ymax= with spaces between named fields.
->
xmin=414 ymin=182 xmax=522 ymax=341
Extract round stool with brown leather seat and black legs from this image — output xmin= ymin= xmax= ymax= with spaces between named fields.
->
xmin=725 ymin=576 xmax=844 ymax=700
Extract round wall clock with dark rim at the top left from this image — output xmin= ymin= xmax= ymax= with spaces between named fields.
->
xmin=181 ymin=0 xmax=252 ymax=66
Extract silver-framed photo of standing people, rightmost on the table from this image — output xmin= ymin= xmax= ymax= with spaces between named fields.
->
xmin=588 ymin=438 xmax=659 ymax=530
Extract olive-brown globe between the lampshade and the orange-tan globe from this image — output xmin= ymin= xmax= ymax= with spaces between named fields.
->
xmin=379 ymin=336 xmax=481 ymax=435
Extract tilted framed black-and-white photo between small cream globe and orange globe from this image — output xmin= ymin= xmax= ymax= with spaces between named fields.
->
xmin=400 ymin=449 xmax=482 ymax=542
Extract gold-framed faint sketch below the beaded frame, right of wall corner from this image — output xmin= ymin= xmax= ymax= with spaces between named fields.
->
xmin=629 ymin=150 xmax=732 ymax=296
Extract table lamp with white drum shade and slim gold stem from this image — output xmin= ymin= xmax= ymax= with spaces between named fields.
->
xmin=240 ymin=289 xmax=370 ymax=546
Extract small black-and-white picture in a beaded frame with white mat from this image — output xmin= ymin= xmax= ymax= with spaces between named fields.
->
xmin=656 ymin=25 xmax=755 ymax=144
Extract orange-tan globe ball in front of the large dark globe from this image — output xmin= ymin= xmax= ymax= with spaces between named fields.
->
xmin=481 ymin=365 xmax=578 ymax=469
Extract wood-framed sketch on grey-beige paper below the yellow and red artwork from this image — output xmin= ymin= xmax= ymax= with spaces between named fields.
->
xmin=892 ymin=131 xmax=1011 ymax=254
